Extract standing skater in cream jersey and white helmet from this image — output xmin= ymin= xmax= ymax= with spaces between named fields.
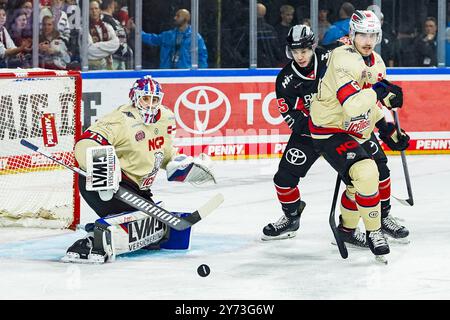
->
xmin=310 ymin=11 xmax=409 ymax=256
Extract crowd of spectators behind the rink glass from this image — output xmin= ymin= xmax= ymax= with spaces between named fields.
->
xmin=0 ymin=0 xmax=442 ymax=70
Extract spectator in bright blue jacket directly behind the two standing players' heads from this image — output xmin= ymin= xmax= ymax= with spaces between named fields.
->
xmin=321 ymin=2 xmax=355 ymax=49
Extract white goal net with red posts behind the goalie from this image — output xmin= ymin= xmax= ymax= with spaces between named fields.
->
xmin=0 ymin=69 xmax=81 ymax=229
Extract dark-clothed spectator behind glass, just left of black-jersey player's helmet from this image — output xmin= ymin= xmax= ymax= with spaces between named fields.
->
xmin=256 ymin=3 xmax=283 ymax=68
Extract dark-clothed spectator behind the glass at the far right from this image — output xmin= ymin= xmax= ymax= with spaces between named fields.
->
xmin=415 ymin=17 xmax=437 ymax=67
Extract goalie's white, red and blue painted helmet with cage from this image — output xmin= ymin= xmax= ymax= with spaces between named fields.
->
xmin=129 ymin=76 xmax=164 ymax=124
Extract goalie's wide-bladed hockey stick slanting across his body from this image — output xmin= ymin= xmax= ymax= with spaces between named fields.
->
xmin=20 ymin=139 xmax=224 ymax=231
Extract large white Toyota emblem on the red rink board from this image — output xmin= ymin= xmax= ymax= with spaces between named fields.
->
xmin=174 ymin=86 xmax=231 ymax=134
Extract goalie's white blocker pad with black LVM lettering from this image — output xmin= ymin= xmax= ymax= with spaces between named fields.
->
xmin=86 ymin=146 xmax=122 ymax=201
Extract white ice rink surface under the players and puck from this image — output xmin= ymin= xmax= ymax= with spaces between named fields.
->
xmin=0 ymin=155 xmax=450 ymax=300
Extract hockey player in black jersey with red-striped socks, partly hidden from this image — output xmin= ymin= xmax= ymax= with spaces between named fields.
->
xmin=262 ymin=25 xmax=409 ymax=248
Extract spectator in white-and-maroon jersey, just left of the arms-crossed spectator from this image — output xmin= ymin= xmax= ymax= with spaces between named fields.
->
xmin=39 ymin=16 xmax=70 ymax=70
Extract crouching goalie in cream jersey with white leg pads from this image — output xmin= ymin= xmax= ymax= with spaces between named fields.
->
xmin=63 ymin=76 xmax=214 ymax=263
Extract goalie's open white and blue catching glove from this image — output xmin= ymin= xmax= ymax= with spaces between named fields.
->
xmin=166 ymin=153 xmax=216 ymax=185
